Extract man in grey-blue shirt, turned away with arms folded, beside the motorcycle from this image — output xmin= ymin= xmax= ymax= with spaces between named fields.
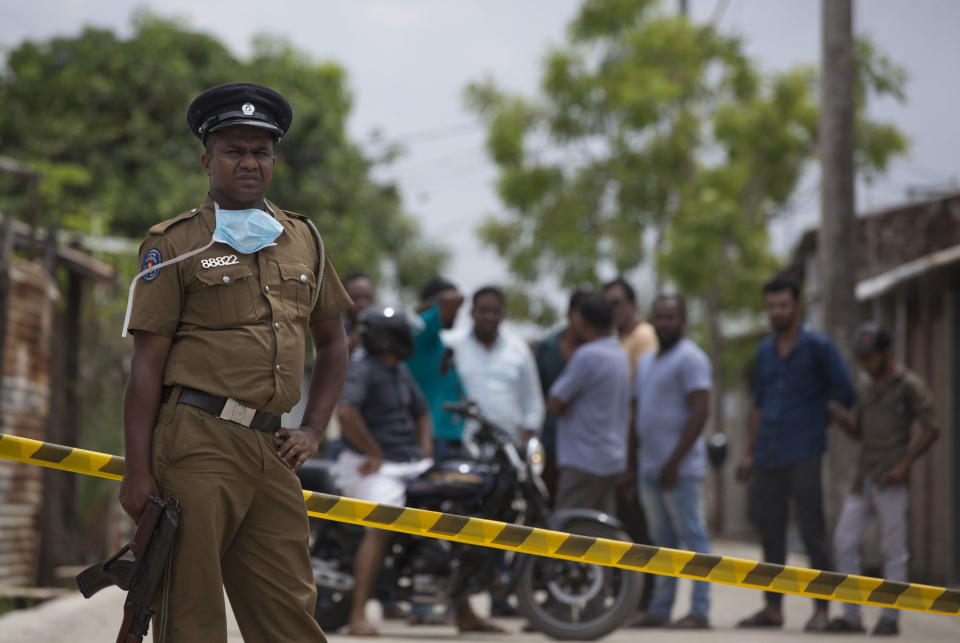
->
xmin=547 ymin=293 xmax=630 ymax=515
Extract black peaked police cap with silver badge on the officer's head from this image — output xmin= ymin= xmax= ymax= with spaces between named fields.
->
xmin=187 ymin=83 xmax=293 ymax=140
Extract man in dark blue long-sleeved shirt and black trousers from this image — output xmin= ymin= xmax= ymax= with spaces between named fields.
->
xmin=737 ymin=278 xmax=854 ymax=632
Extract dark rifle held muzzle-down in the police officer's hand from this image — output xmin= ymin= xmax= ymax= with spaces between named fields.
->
xmin=77 ymin=496 xmax=180 ymax=643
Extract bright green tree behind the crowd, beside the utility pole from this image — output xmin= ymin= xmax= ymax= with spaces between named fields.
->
xmin=466 ymin=0 xmax=906 ymax=432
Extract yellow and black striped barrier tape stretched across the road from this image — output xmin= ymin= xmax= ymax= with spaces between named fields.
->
xmin=0 ymin=434 xmax=960 ymax=616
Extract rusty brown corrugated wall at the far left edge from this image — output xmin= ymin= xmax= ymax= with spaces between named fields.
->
xmin=0 ymin=258 xmax=57 ymax=585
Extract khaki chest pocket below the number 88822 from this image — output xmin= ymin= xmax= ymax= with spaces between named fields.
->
xmin=184 ymin=264 xmax=259 ymax=328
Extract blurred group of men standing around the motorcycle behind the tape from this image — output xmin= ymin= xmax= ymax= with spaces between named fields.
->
xmin=328 ymin=273 xmax=938 ymax=635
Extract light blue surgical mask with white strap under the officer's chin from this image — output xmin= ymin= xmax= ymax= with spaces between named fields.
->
xmin=120 ymin=205 xmax=283 ymax=337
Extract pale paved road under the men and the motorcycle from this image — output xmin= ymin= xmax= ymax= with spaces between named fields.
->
xmin=0 ymin=542 xmax=960 ymax=643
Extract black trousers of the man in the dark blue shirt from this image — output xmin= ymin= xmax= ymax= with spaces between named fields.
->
xmin=753 ymin=455 xmax=833 ymax=607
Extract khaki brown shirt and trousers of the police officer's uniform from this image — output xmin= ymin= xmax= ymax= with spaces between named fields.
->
xmin=130 ymin=195 xmax=351 ymax=643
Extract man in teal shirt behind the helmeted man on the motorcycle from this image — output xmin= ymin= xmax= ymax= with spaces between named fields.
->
xmin=407 ymin=277 xmax=464 ymax=462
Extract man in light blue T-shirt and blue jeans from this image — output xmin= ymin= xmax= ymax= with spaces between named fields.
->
xmin=633 ymin=295 xmax=712 ymax=628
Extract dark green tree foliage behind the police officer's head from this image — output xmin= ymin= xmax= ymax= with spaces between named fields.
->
xmin=0 ymin=13 xmax=445 ymax=287
